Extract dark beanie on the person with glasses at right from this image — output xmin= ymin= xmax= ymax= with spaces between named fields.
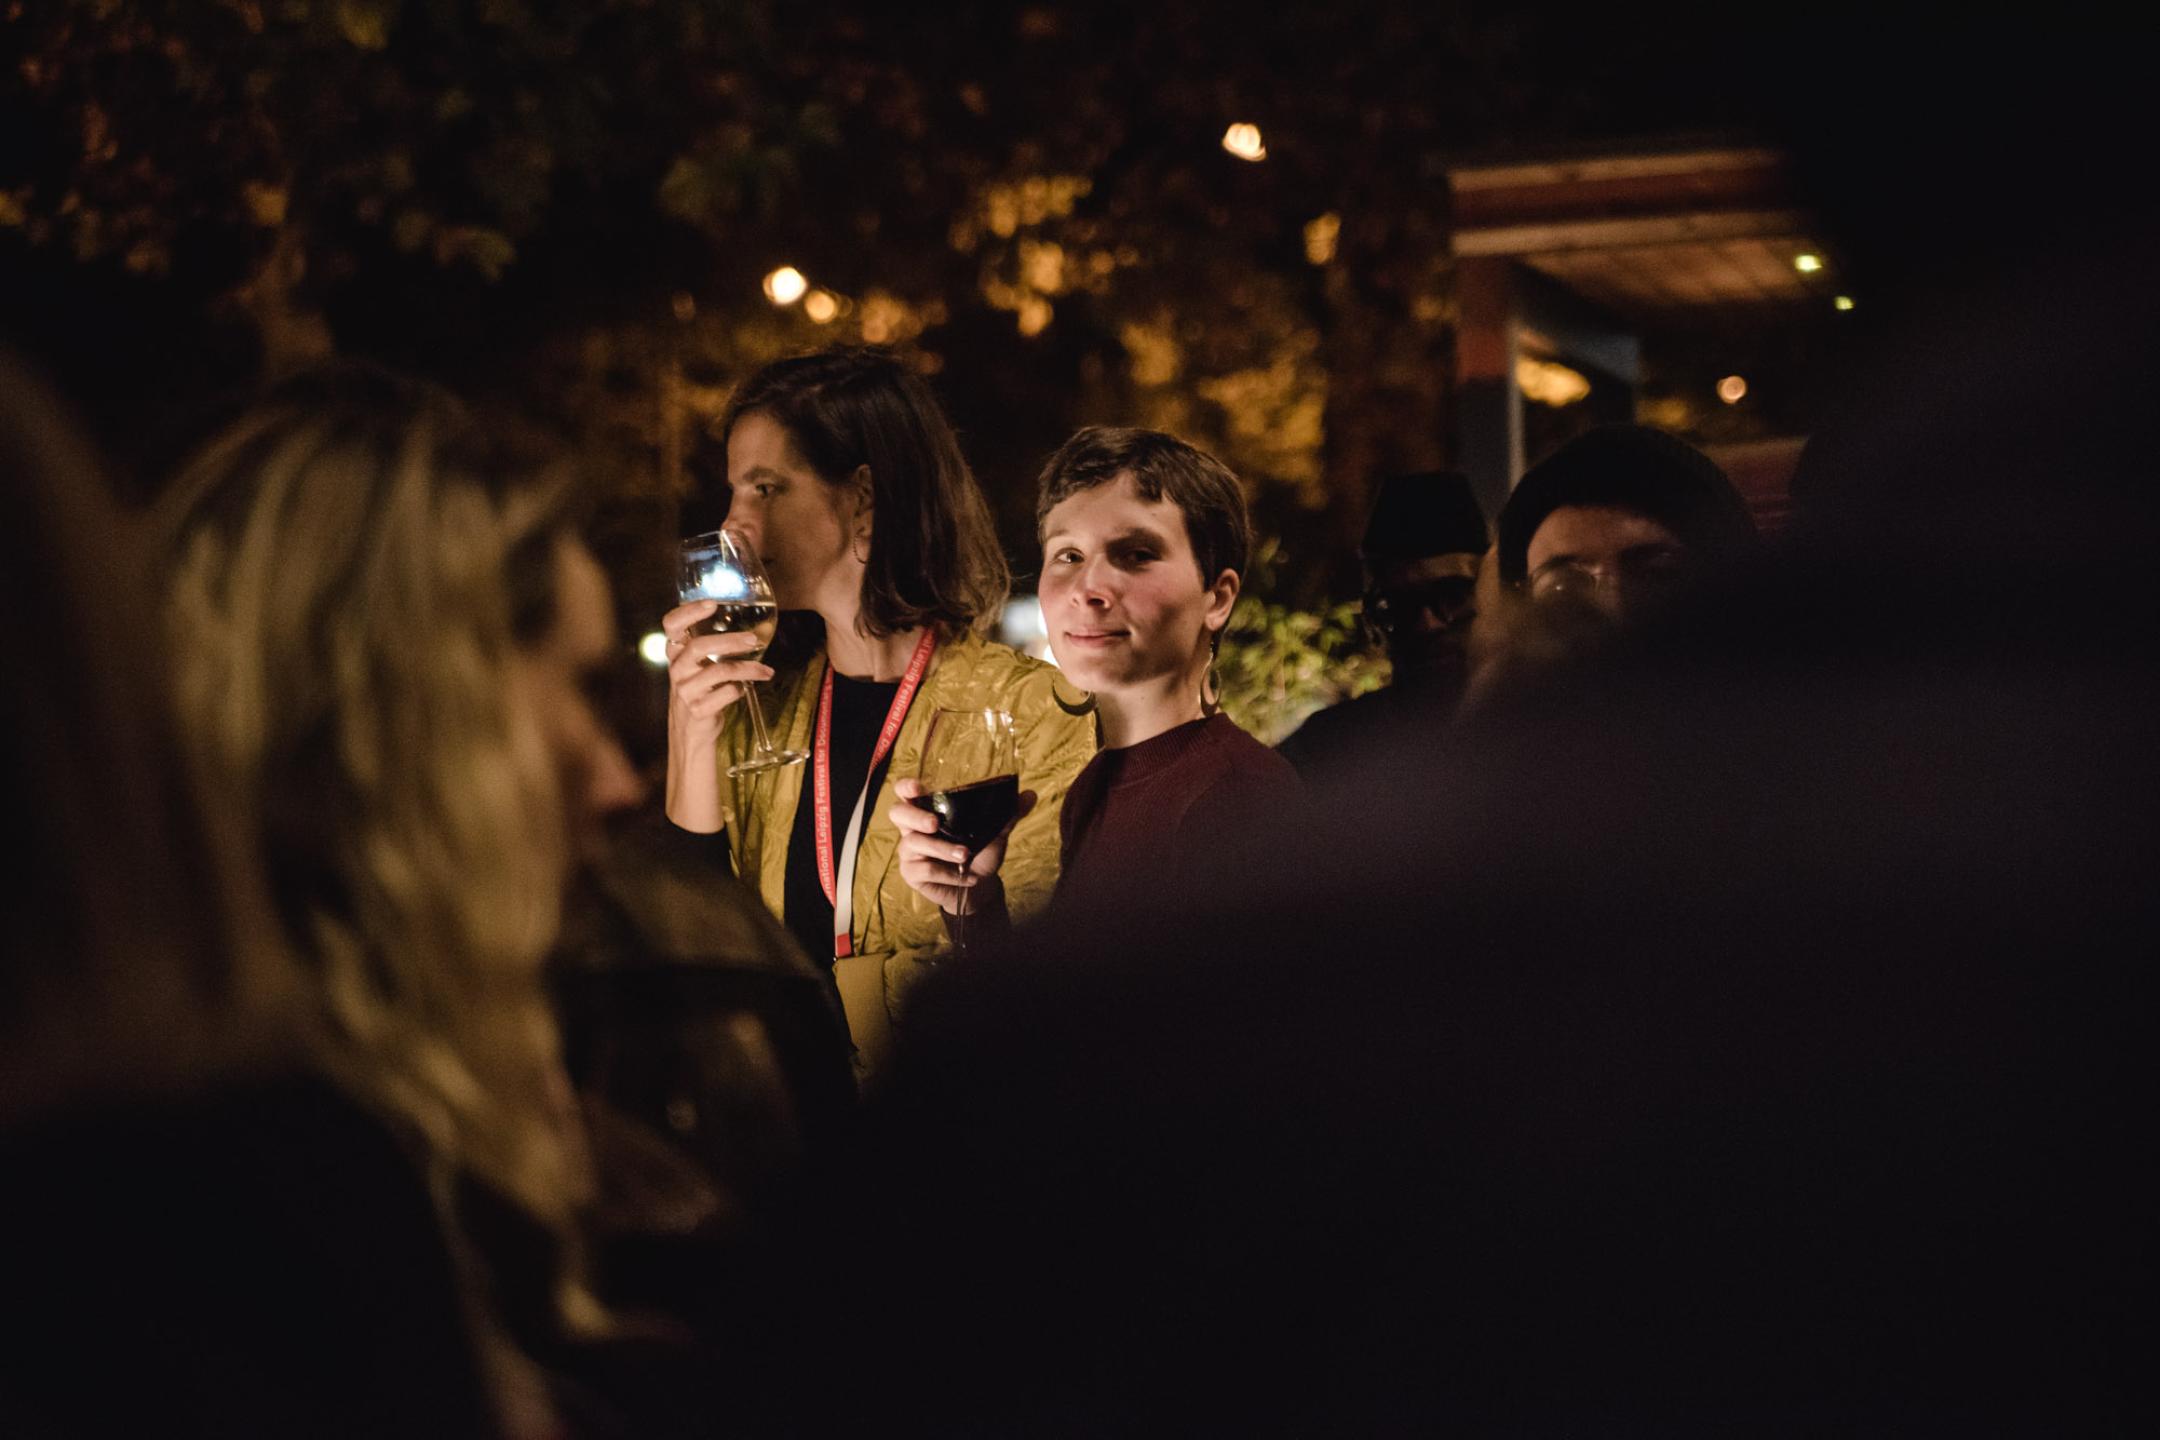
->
xmin=1499 ymin=425 xmax=1756 ymax=581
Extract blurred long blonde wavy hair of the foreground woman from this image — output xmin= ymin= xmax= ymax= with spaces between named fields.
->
xmin=158 ymin=369 xmax=590 ymax=1260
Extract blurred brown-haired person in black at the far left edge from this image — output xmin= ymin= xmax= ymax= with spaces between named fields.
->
xmin=0 ymin=358 xmax=508 ymax=1440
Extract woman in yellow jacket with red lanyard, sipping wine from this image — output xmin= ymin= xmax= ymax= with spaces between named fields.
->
xmin=663 ymin=348 xmax=1095 ymax=1069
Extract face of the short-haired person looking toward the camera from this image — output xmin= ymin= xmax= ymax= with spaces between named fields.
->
xmin=1039 ymin=473 xmax=1238 ymax=695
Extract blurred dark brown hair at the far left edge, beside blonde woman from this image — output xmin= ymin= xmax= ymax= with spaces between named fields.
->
xmin=0 ymin=354 xmax=296 ymax=1120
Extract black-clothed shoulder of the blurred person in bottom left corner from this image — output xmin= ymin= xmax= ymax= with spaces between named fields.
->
xmin=0 ymin=1075 xmax=492 ymax=1438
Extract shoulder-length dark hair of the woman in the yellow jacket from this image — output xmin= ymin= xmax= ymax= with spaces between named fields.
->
xmin=719 ymin=345 xmax=1013 ymax=639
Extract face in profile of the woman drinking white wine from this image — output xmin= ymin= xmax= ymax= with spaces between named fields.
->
xmin=728 ymin=410 xmax=870 ymax=615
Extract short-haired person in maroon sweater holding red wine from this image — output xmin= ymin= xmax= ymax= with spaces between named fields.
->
xmin=890 ymin=425 xmax=1298 ymax=943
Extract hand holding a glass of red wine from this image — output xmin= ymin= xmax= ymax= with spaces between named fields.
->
xmin=888 ymin=710 xmax=1035 ymax=915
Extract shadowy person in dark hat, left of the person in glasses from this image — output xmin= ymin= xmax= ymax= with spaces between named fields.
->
xmin=1274 ymin=471 xmax=1486 ymax=779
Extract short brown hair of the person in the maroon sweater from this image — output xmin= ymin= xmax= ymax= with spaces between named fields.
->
xmin=1035 ymin=425 xmax=1253 ymax=585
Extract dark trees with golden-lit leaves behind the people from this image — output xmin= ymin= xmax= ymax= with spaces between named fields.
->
xmin=0 ymin=0 xmax=1724 ymax=734
